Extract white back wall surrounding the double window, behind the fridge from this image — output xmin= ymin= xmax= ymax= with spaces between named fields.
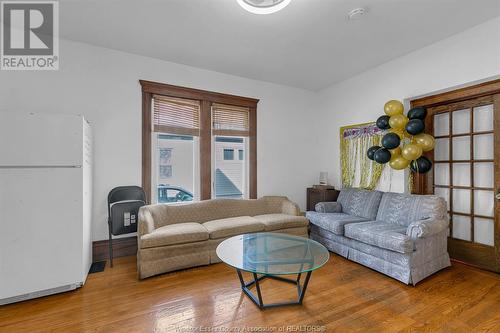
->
xmin=0 ymin=41 xmax=319 ymax=240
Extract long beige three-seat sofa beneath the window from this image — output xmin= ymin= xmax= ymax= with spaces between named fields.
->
xmin=137 ymin=196 xmax=309 ymax=279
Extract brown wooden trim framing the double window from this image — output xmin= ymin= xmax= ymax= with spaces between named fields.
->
xmin=139 ymin=80 xmax=259 ymax=203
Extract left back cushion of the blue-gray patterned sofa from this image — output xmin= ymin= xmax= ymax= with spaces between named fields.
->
xmin=337 ymin=188 xmax=382 ymax=220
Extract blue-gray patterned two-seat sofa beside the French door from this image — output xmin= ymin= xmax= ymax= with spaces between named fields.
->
xmin=306 ymin=188 xmax=450 ymax=285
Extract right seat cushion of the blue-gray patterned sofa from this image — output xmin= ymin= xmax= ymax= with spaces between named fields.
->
xmin=344 ymin=221 xmax=414 ymax=253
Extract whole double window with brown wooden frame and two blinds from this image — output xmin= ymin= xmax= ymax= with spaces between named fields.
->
xmin=140 ymin=81 xmax=258 ymax=203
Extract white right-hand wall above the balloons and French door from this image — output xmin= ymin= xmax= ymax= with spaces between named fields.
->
xmin=318 ymin=18 xmax=500 ymax=192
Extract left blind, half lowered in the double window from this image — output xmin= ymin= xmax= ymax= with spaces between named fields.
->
xmin=153 ymin=95 xmax=200 ymax=136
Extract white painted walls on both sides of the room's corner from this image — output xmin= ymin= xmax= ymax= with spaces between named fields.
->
xmin=0 ymin=18 xmax=500 ymax=240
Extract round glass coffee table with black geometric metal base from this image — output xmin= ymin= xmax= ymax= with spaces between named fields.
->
xmin=216 ymin=232 xmax=330 ymax=309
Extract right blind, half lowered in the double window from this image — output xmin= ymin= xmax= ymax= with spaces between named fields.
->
xmin=212 ymin=104 xmax=250 ymax=136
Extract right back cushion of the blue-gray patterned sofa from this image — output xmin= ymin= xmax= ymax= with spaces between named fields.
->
xmin=377 ymin=192 xmax=447 ymax=227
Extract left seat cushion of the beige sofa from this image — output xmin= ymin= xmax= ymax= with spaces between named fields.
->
xmin=141 ymin=223 xmax=208 ymax=249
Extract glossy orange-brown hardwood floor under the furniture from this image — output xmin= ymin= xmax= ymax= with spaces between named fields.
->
xmin=0 ymin=255 xmax=500 ymax=332
